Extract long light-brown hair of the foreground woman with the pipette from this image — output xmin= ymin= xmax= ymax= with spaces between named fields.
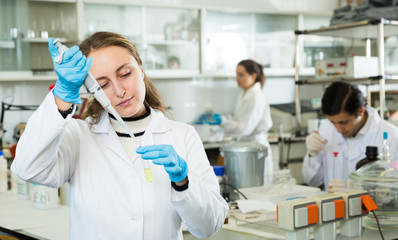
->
xmin=79 ymin=32 xmax=166 ymax=123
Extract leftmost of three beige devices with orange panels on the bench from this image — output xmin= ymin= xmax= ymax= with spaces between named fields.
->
xmin=276 ymin=198 xmax=318 ymax=240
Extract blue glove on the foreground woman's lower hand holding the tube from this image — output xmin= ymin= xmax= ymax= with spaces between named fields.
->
xmin=135 ymin=145 xmax=188 ymax=182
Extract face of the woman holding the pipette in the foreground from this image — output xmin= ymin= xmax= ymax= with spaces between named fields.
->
xmin=88 ymin=46 xmax=145 ymax=117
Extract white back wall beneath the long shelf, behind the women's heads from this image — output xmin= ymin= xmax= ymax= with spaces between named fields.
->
xmin=0 ymin=78 xmax=295 ymax=143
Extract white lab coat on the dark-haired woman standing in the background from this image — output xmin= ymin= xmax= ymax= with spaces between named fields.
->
xmin=221 ymin=82 xmax=274 ymax=175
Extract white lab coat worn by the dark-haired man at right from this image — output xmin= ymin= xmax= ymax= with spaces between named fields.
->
xmin=302 ymin=107 xmax=398 ymax=189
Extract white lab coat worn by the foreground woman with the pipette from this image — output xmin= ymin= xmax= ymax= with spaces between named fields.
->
xmin=11 ymin=93 xmax=228 ymax=240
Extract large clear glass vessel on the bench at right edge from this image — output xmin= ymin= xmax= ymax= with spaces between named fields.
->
xmin=350 ymin=156 xmax=398 ymax=230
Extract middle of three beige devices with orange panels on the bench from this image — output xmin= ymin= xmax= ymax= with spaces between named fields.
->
xmin=312 ymin=193 xmax=345 ymax=240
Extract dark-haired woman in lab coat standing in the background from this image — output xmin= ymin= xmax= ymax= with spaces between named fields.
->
xmin=209 ymin=59 xmax=273 ymax=184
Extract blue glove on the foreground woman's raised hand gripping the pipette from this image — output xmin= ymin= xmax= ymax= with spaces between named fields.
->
xmin=48 ymin=38 xmax=93 ymax=103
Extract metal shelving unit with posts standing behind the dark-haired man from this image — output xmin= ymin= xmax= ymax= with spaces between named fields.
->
xmin=294 ymin=19 xmax=398 ymax=135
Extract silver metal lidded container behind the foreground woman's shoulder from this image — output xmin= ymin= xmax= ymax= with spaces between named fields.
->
xmin=220 ymin=141 xmax=268 ymax=195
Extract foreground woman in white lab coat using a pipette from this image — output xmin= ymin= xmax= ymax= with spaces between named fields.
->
xmin=11 ymin=32 xmax=228 ymax=240
